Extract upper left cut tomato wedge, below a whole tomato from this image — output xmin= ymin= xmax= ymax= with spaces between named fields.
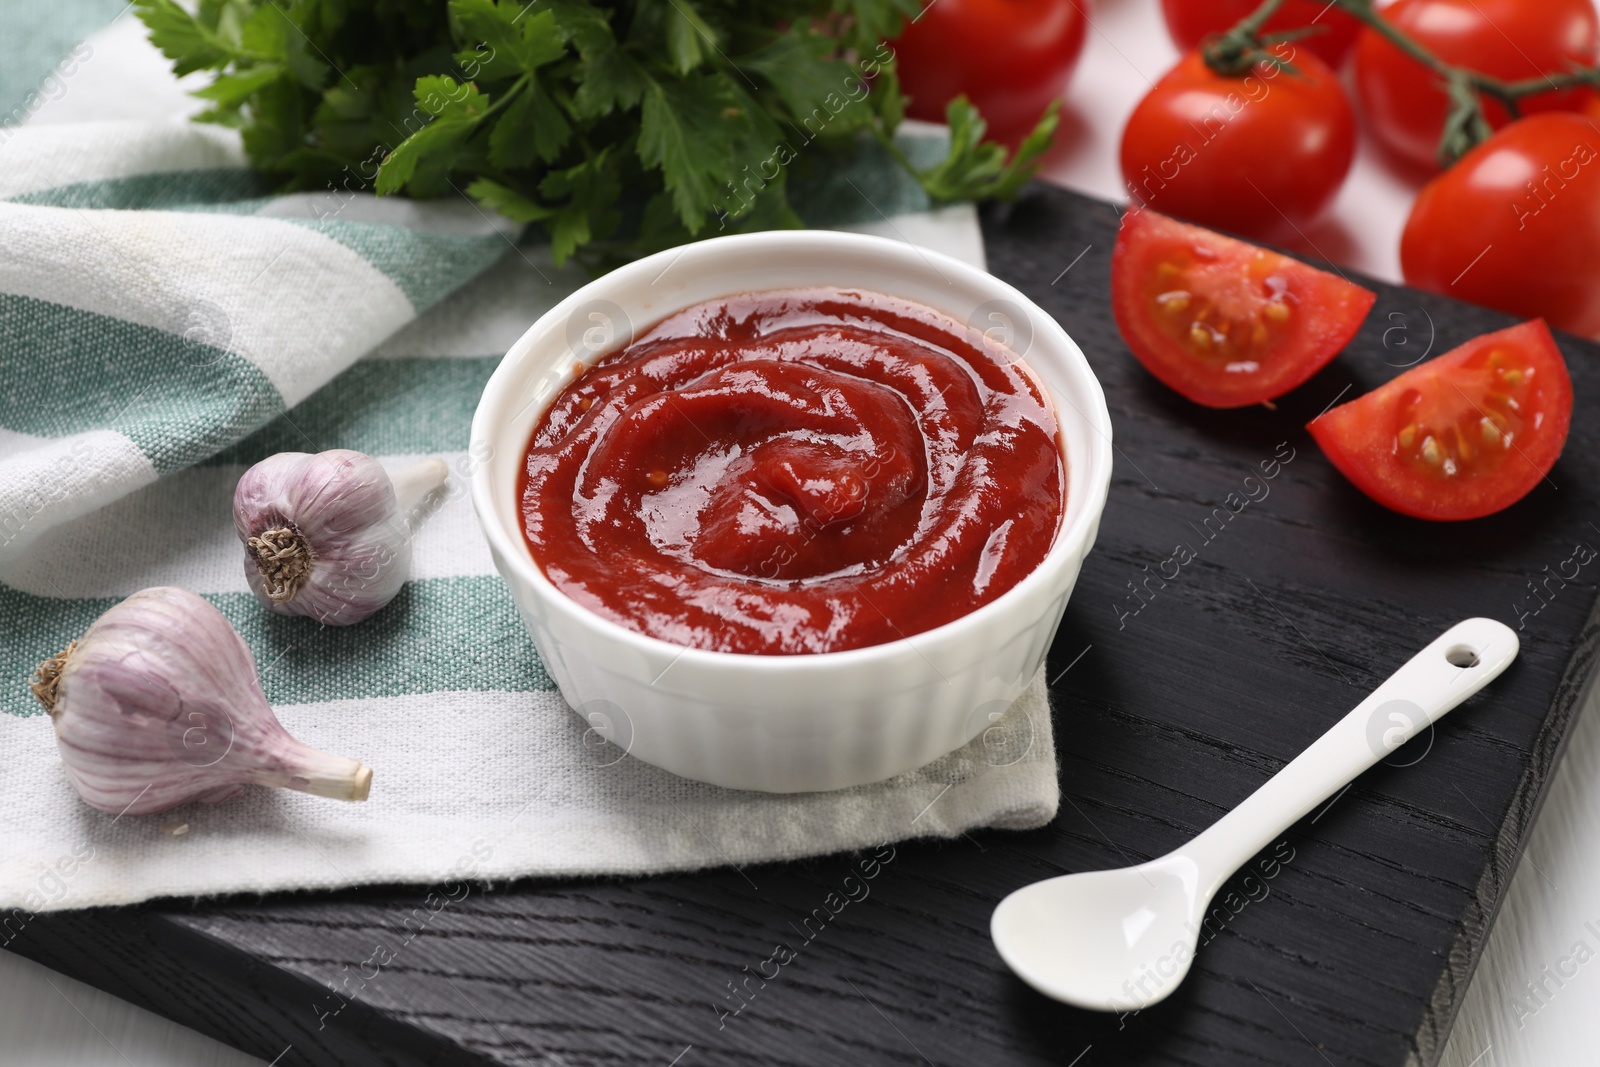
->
xmin=1110 ymin=208 xmax=1378 ymax=408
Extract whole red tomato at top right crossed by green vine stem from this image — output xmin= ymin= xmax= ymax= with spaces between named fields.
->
xmin=1355 ymin=0 xmax=1600 ymax=170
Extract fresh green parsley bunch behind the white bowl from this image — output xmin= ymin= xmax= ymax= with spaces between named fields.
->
xmin=136 ymin=0 xmax=1054 ymax=261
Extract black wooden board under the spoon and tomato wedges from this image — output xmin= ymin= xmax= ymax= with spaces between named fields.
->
xmin=10 ymin=187 xmax=1600 ymax=1067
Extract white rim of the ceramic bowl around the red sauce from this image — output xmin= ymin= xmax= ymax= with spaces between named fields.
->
xmin=469 ymin=230 xmax=1112 ymax=672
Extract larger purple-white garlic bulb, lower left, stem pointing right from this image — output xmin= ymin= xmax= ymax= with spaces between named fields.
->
xmin=32 ymin=587 xmax=373 ymax=814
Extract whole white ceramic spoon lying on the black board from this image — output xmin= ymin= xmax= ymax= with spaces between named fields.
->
xmin=989 ymin=619 xmax=1517 ymax=1011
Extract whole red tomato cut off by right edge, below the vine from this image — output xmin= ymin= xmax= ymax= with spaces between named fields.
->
xmin=1400 ymin=112 xmax=1600 ymax=336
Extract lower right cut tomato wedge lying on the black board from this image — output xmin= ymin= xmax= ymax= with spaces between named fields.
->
xmin=1307 ymin=318 xmax=1573 ymax=520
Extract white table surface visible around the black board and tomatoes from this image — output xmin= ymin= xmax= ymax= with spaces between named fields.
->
xmin=0 ymin=0 xmax=1600 ymax=1067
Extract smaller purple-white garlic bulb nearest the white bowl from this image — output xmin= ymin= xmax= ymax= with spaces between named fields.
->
xmin=234 ymin=448 xmax=448 ymax=625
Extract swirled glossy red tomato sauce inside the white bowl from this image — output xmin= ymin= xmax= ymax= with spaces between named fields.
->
xmin=520 ymin=290 xmax=1066 ymax=654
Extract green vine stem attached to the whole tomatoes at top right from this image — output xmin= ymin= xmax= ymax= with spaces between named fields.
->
xmin=1202 ymin=0 xmax=1600 ymax=166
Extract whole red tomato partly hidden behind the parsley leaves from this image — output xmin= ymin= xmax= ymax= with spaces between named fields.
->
xmin=893 ymin=0 xmax=1088 ymax=144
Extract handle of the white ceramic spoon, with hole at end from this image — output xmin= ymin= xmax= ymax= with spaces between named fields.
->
xmin=1178 ymin=619 xmax=1518 ymax=896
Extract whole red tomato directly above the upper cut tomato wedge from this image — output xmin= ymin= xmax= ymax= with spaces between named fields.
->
xmin=1122 ymin=45 xmax=1355 ymax=242
